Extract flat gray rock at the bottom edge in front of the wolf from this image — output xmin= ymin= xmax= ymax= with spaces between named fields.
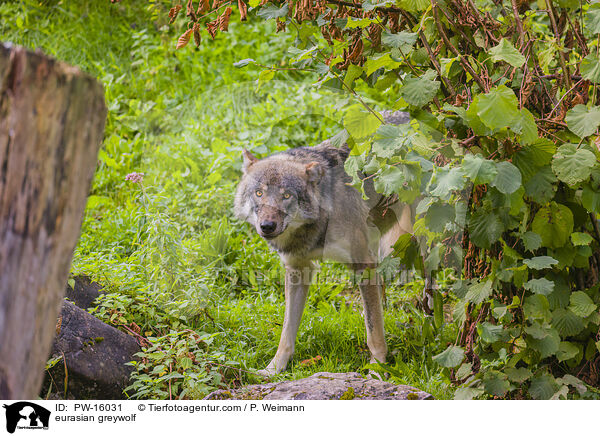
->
xmin=204 ymin=372 xmax=433 ymax=400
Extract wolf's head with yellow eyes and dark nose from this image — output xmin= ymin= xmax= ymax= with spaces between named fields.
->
xmin=234 ymin=150 xmax=323 ymax=243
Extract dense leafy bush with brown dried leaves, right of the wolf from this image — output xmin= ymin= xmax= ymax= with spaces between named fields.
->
xmin=172 ymin=0 xmax=600 ymax=399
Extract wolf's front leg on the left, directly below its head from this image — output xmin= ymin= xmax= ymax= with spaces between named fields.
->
xmin=258 ymin=264 xmax=314 ymax=376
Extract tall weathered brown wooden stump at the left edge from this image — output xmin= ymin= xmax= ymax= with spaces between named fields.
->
xmin=0 ymin=44 xmax=106 ymax=399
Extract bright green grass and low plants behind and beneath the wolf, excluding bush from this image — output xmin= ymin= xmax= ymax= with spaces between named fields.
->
xmin=0 ymin=0 xmax=452 ymax=398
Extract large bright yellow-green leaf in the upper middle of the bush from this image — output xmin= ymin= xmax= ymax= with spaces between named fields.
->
xmin=477 ymin=85 xmax=519 ymax=129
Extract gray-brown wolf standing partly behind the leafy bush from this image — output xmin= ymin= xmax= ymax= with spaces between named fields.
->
xmin=234 ymin=112 xmax=413 ymax=376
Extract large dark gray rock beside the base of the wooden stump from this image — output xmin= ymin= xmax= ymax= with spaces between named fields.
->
xmin=40 ymin=301 xmax=140 ymax=400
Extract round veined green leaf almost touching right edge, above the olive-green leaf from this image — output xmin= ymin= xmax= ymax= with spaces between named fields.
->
xmin=552 ymin=144 xmax=596 ymax=187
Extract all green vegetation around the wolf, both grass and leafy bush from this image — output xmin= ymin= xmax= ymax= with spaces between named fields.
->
xmin=0 ymin=0 xmax=600 ymax=399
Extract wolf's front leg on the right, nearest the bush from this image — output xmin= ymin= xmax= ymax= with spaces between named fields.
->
xmin=360 ymin=270 xmax=387 ymax=363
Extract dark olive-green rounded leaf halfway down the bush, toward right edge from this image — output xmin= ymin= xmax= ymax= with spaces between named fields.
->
xmin=531 ymin=201 xmax=573 ymax=248
